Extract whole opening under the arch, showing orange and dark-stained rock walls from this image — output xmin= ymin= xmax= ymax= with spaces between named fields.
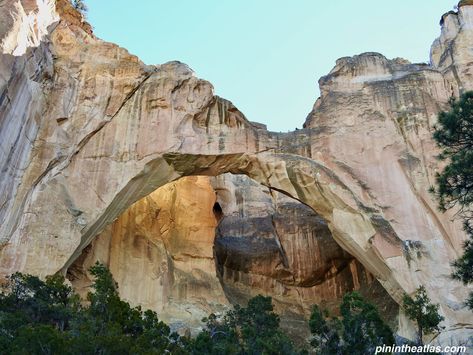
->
xmin=67 ymin=174 xmax=398 ymax=341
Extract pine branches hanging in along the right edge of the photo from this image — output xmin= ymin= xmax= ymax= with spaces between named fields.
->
xmin=434 ymin=91 xmax=473 ymax=309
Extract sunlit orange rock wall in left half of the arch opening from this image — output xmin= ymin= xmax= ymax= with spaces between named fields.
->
xmin=68 ymin=176 xmax=228 ymax=336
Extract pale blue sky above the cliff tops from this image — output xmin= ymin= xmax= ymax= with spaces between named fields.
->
xmin=85 ymin=0 xmax=458 ymax=132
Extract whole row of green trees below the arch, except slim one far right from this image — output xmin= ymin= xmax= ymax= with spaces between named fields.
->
xmin=0 ymin=264 xmax=394 ymax=355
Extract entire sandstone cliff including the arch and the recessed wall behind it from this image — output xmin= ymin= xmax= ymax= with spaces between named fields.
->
xmin=0 ymin=0 xmax=473 ymax=341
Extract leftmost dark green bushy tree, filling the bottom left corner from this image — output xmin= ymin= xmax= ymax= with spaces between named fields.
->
xmin=0 ymin=273 xmax=81 ymax=354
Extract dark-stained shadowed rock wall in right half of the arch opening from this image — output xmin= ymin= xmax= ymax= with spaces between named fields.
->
xmin=212 ymin=174 xmax=398 ymax=339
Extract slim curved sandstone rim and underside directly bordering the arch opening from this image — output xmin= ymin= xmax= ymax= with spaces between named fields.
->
xmin=58 ymin=153 xmax=402 ymax=301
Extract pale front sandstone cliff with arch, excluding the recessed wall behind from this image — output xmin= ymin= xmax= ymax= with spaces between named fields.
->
xmin=0 ymin=0 xmax=473 ymax=344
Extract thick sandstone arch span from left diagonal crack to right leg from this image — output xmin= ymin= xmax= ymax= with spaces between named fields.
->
xmin=1 ymin=55 xmax=454 ymax=320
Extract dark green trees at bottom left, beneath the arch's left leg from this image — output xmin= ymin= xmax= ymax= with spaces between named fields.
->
xmin=0 ymin=265 xmax=185 ymax=354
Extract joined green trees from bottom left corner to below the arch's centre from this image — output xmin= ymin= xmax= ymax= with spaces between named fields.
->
xmin=0 ymin=264 xmax=297 ymax=355
